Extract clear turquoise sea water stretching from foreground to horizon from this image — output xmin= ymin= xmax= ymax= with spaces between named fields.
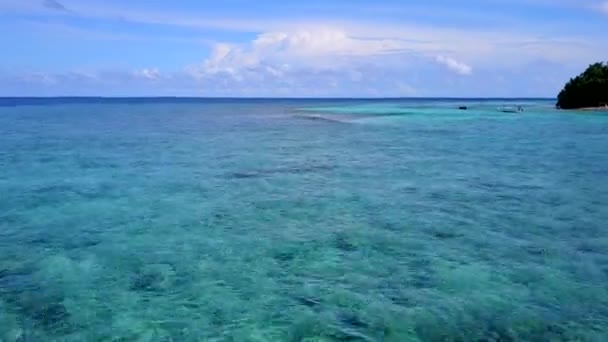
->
xmin=0 ymin=99 xmax=608 ymax=341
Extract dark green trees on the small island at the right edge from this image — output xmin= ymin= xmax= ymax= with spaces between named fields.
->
xmin=556 ymin=63 xmax=608 ymax=109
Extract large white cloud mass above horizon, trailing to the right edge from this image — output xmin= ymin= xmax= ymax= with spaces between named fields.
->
xmin=186 ymin=24 xmax=605 ymax=95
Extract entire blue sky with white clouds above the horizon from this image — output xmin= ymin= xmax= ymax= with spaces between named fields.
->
xmin=0 ymin=0 xmax=608 ymax=97
